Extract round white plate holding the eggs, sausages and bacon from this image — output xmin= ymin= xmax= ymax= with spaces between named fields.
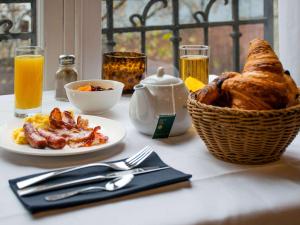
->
xmin=0 ymin=115 xmax=126 ymax=156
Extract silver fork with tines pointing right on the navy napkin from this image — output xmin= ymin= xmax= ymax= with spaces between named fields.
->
xmin=17 ymin=146 xmax=153 ymax=189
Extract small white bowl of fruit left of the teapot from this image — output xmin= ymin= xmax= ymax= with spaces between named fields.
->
xmin=65 ymin=80 xmax=124 ymax=114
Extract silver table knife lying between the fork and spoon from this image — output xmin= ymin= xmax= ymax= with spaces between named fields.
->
xmin=17 ymin=166 xmax=170 ymax=196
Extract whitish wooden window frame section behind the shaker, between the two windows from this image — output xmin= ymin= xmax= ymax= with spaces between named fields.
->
xmin=37 ymin=0 xmax=102 ymax=90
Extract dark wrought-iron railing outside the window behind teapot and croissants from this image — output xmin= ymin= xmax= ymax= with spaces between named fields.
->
xmin=102 ymin=0 xmax=275 ymax=76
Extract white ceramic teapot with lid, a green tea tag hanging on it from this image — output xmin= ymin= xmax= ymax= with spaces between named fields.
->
xmin=129 ymin=67 xmax=191 ymax=136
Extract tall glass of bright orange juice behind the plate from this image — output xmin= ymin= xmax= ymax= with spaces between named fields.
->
xmin=14 ymin=46 xmax=44 ymax=118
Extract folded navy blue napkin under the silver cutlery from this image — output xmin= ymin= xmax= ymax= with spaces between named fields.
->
xmin=9 ymin=152 xmax=191 ymax=213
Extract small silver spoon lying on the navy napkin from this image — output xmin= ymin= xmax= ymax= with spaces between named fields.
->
xmin=45 ymin=174 xmax=134 ymax=201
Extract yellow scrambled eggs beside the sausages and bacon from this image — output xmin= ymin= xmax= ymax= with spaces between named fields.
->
xmin=12 ymin=114 xmax=50 ymax=145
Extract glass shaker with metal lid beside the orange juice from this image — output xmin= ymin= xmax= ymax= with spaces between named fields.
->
xmin=55 ymin=55 xmax=78 ymax=101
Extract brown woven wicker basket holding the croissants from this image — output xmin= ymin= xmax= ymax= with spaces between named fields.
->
xmin=188 ymin=94 xmax=300 ymax=164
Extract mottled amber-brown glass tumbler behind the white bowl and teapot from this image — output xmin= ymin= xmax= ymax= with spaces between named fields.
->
xmin=102 ymin=52 xmax=147 ymax=93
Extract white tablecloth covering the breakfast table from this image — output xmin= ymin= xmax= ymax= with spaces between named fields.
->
xmin=0 ymin=92 xmax=300 ymax=225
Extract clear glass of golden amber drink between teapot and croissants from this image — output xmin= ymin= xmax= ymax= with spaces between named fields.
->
xmin=179 ymin=45 xmax=209 ymax=91
